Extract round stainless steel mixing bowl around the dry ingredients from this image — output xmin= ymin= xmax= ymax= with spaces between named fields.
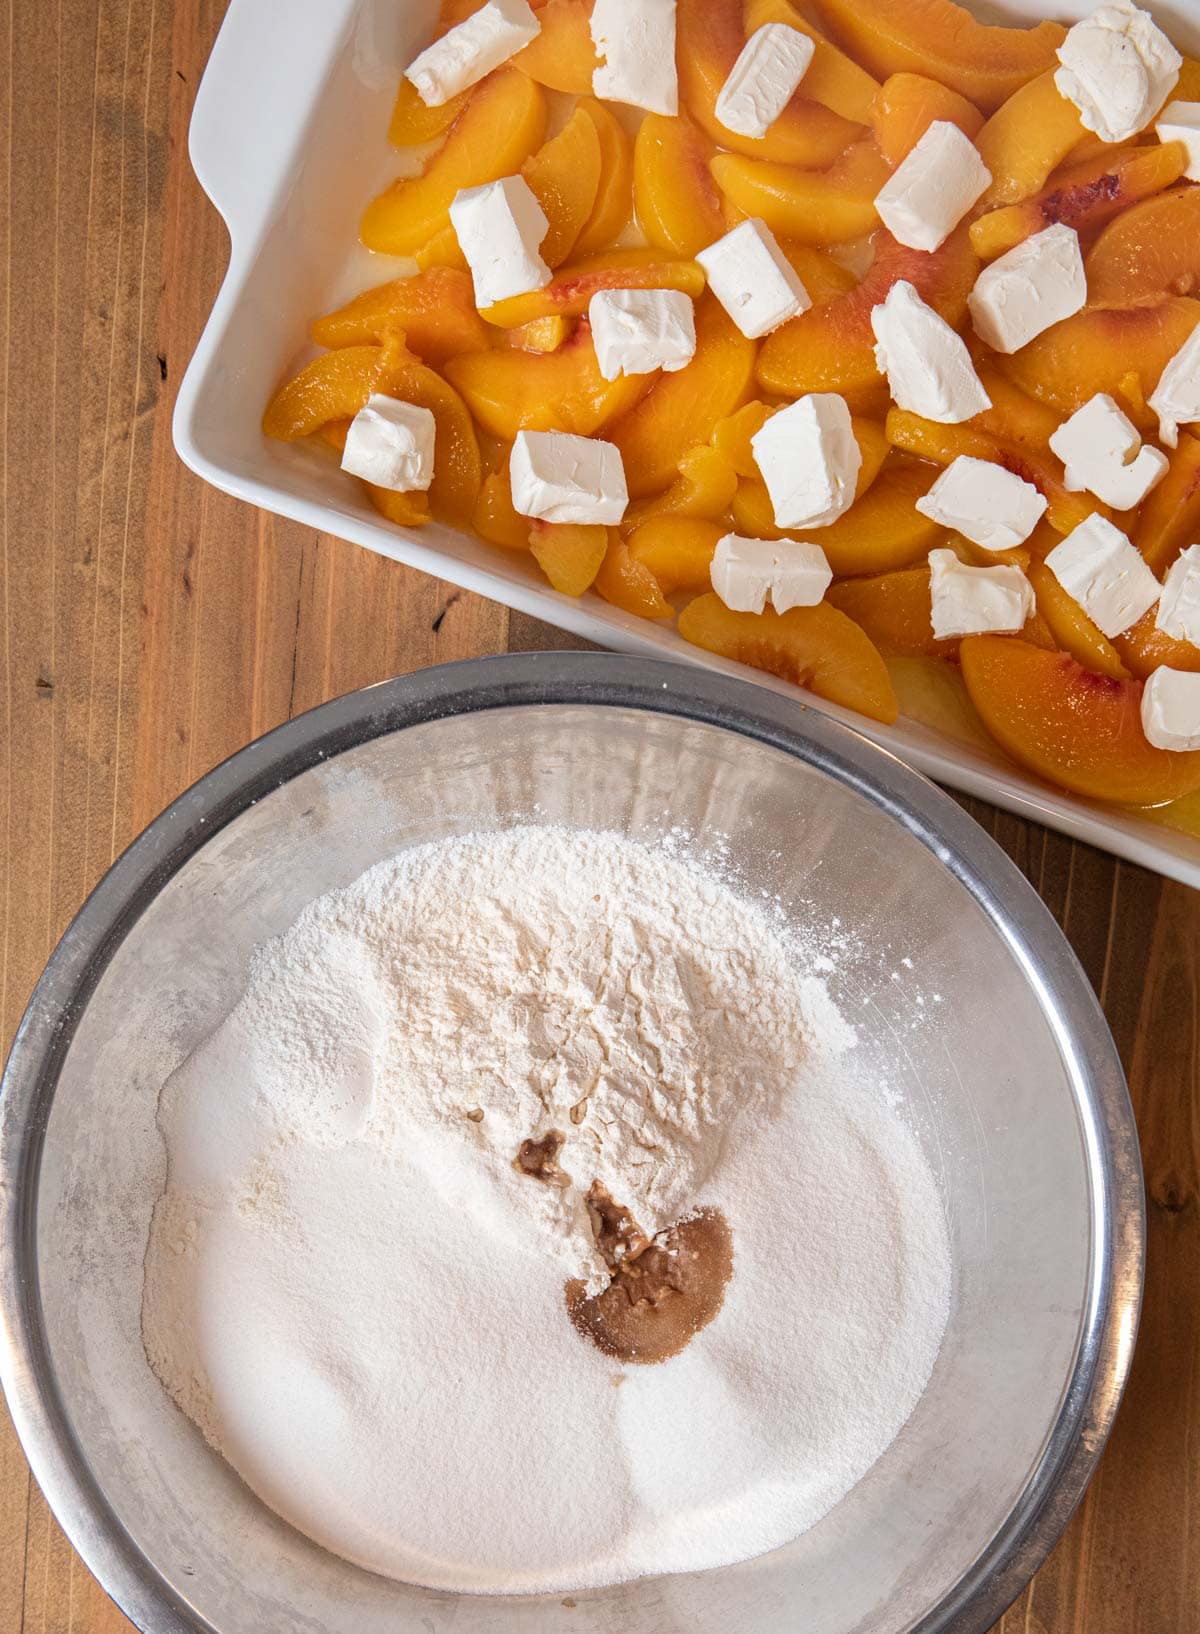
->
xmin=0 ymin=654 xmax=1143 ymax=1634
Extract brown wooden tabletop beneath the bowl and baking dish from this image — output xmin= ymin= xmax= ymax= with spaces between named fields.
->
xmin=0 ymin=0 xmax=1200 ymax=1634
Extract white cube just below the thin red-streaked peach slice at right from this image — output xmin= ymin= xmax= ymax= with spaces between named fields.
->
xmin=968 ymin=222 xmax=1087 ymax=351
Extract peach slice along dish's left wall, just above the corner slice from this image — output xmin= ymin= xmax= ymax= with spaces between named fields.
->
xmin=309 ymin=266 xmax=489 ymax=366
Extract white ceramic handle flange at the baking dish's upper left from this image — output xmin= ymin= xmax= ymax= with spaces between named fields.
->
xmin=188 ymin=0 xmax=358 ymax=252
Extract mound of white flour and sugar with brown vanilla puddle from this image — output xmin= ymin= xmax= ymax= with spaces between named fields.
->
xmin=142 ymin=827 xmax=951 ymax=1593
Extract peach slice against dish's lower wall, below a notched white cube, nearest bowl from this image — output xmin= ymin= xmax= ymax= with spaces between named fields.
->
xmin=678 ymin=593 xmax=898 ymax=722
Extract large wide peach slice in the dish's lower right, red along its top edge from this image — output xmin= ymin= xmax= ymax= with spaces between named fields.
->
xmin=960 ymin=636 xmax=1200 ymax=806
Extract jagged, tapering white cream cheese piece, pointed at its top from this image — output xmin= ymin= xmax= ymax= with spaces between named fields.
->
xmin=871 ymin=279 xmax=992 ymax=425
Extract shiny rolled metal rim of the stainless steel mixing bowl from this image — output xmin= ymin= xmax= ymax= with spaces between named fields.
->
xmin=0 ymin=652 xmax=1144 ymax=1634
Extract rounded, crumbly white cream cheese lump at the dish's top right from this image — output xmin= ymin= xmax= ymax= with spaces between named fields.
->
xmin=1054 ymin=0 xmax=1184 ymax=142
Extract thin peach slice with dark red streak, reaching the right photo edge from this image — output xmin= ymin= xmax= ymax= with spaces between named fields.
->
xmin=971 ymin=142 xmax=1187 ymax=261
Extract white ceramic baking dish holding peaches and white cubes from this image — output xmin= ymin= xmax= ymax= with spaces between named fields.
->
xmin=173 ymin=0 xmax=1200 ymax=886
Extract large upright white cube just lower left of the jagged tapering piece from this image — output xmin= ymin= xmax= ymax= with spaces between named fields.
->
xmin=750 ymin=392 xmax=863 ymax=528
